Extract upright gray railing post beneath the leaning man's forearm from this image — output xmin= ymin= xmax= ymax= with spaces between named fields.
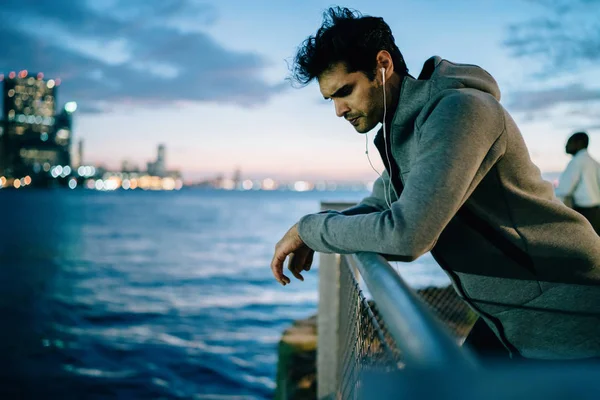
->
xmin=317 ymin=203 xmax=354 ymax=399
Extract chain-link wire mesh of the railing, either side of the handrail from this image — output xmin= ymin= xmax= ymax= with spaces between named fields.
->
xmin=337 ymin=257 xmax=476 ymax=400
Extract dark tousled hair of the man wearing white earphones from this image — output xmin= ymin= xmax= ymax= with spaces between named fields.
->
xmin=290 ymin=7 xmax=408 ymax=86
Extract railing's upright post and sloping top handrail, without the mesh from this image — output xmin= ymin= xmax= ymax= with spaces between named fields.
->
xmin=317 ymin=202 xmax=476 ymax=399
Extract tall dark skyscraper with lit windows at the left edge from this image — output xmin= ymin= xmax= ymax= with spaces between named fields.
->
xmin=0 ymin=70 xmax=62 ymax=176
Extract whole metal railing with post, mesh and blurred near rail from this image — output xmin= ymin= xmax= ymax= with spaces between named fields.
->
xmin=317 ymin=203 xmax=600 ymax=400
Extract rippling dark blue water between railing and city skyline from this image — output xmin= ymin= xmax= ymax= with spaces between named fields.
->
xmin=0 ymin=190 xmax=444 ymax=399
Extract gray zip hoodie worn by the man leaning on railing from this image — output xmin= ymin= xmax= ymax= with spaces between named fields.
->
xmin=298 ymin=57 xmax=600 ymax=359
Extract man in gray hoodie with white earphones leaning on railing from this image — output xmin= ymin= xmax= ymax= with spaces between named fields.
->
xmin=271 ymin=8 xmax=600 ymax=360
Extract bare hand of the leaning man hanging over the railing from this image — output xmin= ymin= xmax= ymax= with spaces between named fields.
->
xmin=271 ymin=224 xmax=315 ymax=286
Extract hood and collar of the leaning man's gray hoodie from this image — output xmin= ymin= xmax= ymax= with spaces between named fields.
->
xmin=392 ymin=56 xmax=500 ymax=125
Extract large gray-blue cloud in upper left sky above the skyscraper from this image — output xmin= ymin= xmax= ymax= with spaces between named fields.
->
xmin=0 ymin=0 xmax=287 ymax=112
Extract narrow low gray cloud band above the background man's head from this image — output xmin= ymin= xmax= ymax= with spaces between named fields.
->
xmin=509 ymin=85 xmax=600 ymax=112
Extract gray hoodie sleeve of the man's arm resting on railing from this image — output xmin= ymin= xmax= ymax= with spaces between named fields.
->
xmin=298 ymin=91 xmax=506 ymax=260
